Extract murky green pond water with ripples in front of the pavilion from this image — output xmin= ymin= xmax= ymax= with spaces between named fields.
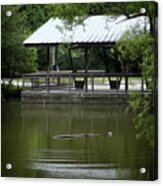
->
xmin=2 ymin=100 xmax=154 ymax=180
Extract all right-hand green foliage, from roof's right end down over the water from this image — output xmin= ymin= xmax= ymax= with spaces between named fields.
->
xmin=117 ymin=33 xmax=156 ymax=146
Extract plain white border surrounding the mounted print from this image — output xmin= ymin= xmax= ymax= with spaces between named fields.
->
xmin=0 ymin=0 xmax=163 ymax=186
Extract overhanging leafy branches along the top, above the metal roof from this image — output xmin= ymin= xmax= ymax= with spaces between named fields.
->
xmin=45 ymin=1 xmax=157 ymax=36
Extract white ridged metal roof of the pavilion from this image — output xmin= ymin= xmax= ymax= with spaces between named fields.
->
xmin=23 ymin=16 xmax=149 ymax=45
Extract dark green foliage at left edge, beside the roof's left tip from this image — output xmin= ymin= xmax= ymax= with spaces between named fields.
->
xmin=1 ymin=5 xmax=37 ymax=79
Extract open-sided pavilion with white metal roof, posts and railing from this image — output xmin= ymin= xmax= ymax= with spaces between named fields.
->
xmin=23 ymin=16 xmax=149 ymax=92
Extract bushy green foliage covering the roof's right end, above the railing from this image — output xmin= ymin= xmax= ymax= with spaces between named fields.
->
xmin=117 ymin=32 xmax=154 ymax=74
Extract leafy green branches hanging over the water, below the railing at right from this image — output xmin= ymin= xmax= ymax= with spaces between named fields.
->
xmin=130 ymin=93 xmax=156 ymax=146
